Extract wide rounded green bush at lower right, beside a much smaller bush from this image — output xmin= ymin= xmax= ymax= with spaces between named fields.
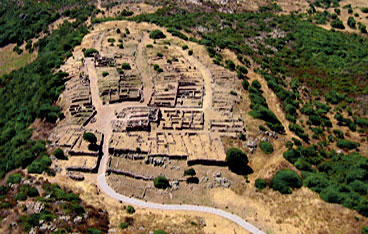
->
xmin=271 ymin=169 xmax=303 ymax=194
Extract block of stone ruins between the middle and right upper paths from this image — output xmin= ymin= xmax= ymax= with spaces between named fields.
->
xmin=147 ymin=47 xmax=204 ymax=108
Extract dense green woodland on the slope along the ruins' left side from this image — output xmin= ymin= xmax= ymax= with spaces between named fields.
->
xmin=0 ymin=3 xmax=94 ymax=177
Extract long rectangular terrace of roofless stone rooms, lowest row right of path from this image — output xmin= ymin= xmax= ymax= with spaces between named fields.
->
xmin=109 ymin=132 xmax=226 ymax=165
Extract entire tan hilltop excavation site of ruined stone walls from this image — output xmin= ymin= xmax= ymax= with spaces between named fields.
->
xmin=49 ymin=21 xmax=245 ymax=201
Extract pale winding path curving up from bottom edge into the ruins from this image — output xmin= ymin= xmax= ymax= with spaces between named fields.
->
xmin=86 ymin=29 xmax=264 ymax=234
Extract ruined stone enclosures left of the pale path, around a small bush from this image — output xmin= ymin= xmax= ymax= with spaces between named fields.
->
xmin=50 ymin=126 xmax=104 ymax=173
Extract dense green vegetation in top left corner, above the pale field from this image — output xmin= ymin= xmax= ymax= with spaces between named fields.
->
xmin=0 ymin=0 xmax=93 ymax=47
